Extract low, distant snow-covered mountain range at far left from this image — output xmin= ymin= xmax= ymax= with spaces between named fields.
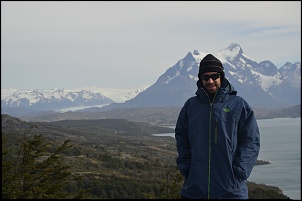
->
xmin=1 ymin=86 xmax=147 ymax=111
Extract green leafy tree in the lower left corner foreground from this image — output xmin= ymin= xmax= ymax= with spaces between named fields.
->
xmin=2 ymin=125 xmax=85 ymax=199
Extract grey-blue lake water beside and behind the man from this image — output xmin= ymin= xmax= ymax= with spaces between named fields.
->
xmin=154 ymin=118 xmax=301 ymax=200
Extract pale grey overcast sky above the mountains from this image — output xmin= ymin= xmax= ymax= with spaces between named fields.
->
xmin=1 ymin=1 xmax=301 ymax=89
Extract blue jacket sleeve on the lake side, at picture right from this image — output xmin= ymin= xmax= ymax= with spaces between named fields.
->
xmin=233 ymin=101 xmax=260 ymax=182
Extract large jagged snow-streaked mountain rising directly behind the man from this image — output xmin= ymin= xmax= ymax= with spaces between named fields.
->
xmin=102 ymin=43 xmax=301 ymax=110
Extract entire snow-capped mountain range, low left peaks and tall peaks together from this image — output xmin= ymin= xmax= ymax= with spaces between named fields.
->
xmin=1 ymin=43 xmax=301 ymax=115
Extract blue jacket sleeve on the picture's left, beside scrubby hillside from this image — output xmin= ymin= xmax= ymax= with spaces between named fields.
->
xmin=175 ymin=105 xmax=191 ymax=178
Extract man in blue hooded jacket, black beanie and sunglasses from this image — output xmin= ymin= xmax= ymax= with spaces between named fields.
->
xmin=175 ymin=54 xmax=260 ymax=199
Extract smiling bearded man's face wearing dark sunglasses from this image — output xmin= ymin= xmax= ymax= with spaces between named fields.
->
xmin=200 ymin=72 xmax=221 ymax=95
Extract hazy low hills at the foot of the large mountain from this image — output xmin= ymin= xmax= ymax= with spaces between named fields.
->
xmin=19 ymin=105 xmax=301 ymax=125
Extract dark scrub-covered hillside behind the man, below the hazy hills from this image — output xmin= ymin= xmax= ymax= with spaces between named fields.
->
xmin=2 ymin=115 xmax=288 ymax=199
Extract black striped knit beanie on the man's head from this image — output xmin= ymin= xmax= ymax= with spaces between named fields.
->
xmin=198 ymin=54 xmax=224 ymax=81
